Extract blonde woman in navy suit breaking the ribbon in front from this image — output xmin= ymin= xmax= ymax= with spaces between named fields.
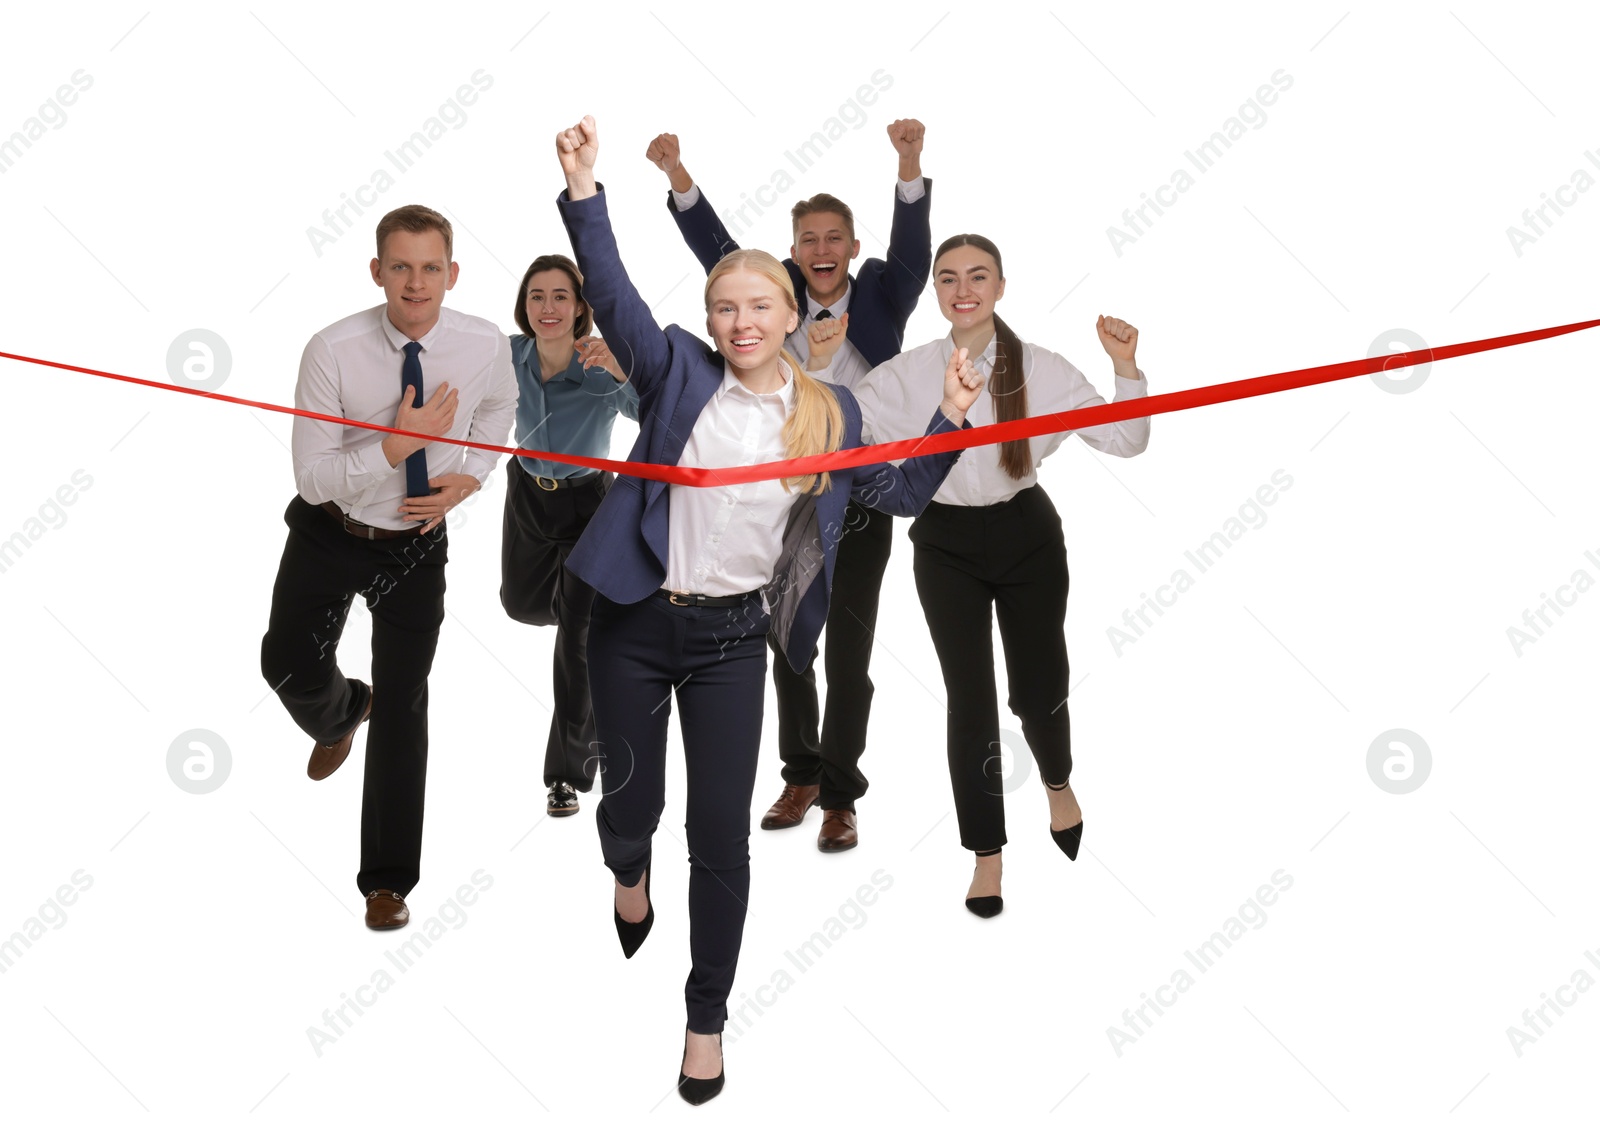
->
xmin=555 ymin=117 xmax=982 ymax=1104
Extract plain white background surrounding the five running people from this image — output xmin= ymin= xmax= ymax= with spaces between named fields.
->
xmin=0 ymin=3 xmax=1600 ymax=1122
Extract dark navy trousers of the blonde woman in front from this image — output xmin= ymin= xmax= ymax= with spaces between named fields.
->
xmin=589 ymin=595 xmax=768 ymax=1035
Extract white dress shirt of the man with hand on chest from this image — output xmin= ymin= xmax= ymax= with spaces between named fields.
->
xmin=293 ymin=306 xmax=517 ymax=530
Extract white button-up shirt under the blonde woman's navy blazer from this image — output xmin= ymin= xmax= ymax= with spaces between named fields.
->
xmin=662 ymin=362 xmax=795 ymax=597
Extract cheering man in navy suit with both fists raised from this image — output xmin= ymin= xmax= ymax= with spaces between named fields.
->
xmin=645 ymin=118 xmax=936 ymax=851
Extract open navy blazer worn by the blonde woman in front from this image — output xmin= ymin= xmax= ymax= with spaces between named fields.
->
xmin=557 ymin=187 xmax=971 ymax=672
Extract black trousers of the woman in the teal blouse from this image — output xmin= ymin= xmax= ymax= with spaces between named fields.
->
xmin=501 ymin=458 xmax=613 ymax=792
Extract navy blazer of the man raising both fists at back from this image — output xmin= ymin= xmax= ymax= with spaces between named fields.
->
xmin=667 ymin=176 xmax=933 ymax=366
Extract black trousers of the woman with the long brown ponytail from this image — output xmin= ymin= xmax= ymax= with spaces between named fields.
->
xmin=910 ymin=485 xmax=1072 ymax=851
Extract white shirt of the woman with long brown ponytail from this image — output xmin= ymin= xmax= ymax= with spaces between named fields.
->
xmin=851 ymin=336 xmax=1150 ymax=507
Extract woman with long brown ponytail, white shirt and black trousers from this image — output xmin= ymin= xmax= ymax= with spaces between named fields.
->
xmin=851 ymin=234 xmax=1150 ymax=919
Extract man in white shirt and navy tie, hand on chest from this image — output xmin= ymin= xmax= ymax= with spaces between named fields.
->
xmin=261 ymin=205 xmax=517 ymax=930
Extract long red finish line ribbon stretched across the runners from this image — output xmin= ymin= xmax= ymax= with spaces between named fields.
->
xmin=0 ymin=320 xmax=1600 ymax=488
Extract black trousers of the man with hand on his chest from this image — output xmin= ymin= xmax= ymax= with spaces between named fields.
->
xmin=261 ymin=496 xmax=446 ymax=895
